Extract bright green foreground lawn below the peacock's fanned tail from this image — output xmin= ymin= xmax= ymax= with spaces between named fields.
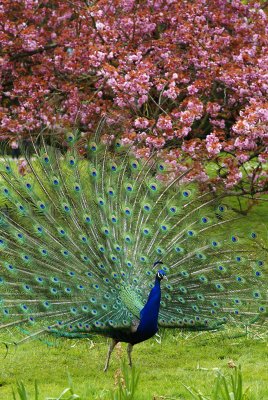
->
xmin=0 ymin=331 xmax=268 ymax=400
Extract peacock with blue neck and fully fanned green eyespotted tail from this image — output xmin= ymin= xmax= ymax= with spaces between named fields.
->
xmin=0 ymin=133 xmax=267 ymax=371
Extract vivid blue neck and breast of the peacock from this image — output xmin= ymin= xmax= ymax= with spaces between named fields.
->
xmin=137 ymin=279 xmax=161 ymax=337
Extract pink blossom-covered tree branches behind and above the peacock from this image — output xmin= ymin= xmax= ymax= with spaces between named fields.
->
xmin=0 ymin=0 xmax=268 ymax=195
